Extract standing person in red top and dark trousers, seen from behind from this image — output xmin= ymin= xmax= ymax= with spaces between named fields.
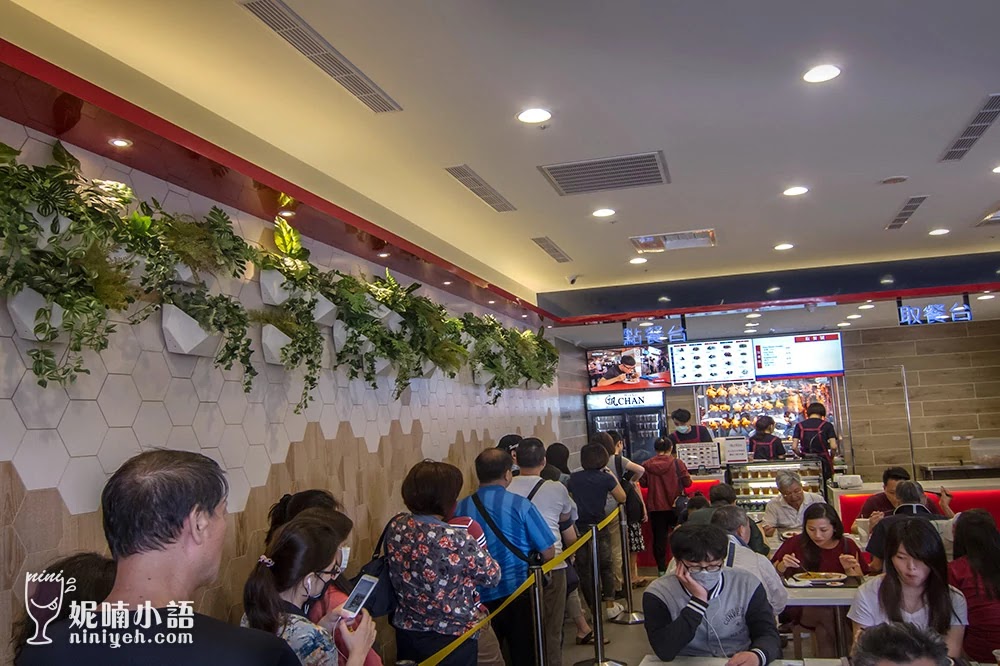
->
xmin=639 ymin=437 xmax=692 ymax=576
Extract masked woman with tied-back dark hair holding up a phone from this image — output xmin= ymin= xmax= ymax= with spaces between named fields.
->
xmin=242 ymin=509 xmax=375 ymax=666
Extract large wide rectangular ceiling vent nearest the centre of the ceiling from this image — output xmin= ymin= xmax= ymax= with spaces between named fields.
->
xmin=538 ymin=151 xmax=670 ymax=196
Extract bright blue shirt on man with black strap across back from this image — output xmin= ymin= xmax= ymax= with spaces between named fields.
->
xmin=455 ymin=486 xmax=556 ymax=601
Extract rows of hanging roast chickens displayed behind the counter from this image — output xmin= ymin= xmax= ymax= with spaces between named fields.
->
xmin=695 ymin=377 xmax=838 ymax=438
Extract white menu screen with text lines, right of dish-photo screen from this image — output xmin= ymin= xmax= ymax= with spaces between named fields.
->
xmin=753 ymin=333 xmax=844 ymax=379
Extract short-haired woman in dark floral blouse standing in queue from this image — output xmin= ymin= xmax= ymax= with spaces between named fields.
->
xmin=385 ymin=460 xmax=500 ymax=666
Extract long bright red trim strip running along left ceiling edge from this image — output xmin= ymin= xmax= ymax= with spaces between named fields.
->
xmin=0 ymin=39 xmax=555 ymax=320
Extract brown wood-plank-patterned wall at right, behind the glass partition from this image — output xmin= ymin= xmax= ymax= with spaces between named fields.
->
xmin=844 ymin=321 xmax=1000 ymax=481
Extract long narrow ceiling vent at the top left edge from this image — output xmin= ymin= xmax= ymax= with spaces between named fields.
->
xmin=237 ymin=0 xmax=403 ymax=113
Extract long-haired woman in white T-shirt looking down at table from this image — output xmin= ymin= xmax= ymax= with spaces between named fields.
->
xmin=847 ymin=518 xmax=969 ymax=658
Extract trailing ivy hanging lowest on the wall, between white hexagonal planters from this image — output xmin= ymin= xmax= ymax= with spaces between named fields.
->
xmin=250 ymin=296 xmax=323 ymax=414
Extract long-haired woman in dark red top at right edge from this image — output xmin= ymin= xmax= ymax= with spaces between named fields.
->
xmin=948 ymin=509 xmax=1000 ymax=663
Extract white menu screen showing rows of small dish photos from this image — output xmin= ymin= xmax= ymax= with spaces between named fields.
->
xmin=670 ymin=338 xmax=756 ymax=386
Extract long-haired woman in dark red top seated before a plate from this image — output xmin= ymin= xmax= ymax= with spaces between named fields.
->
xmin=772 ymin=504 xmax=868 ymax=657
